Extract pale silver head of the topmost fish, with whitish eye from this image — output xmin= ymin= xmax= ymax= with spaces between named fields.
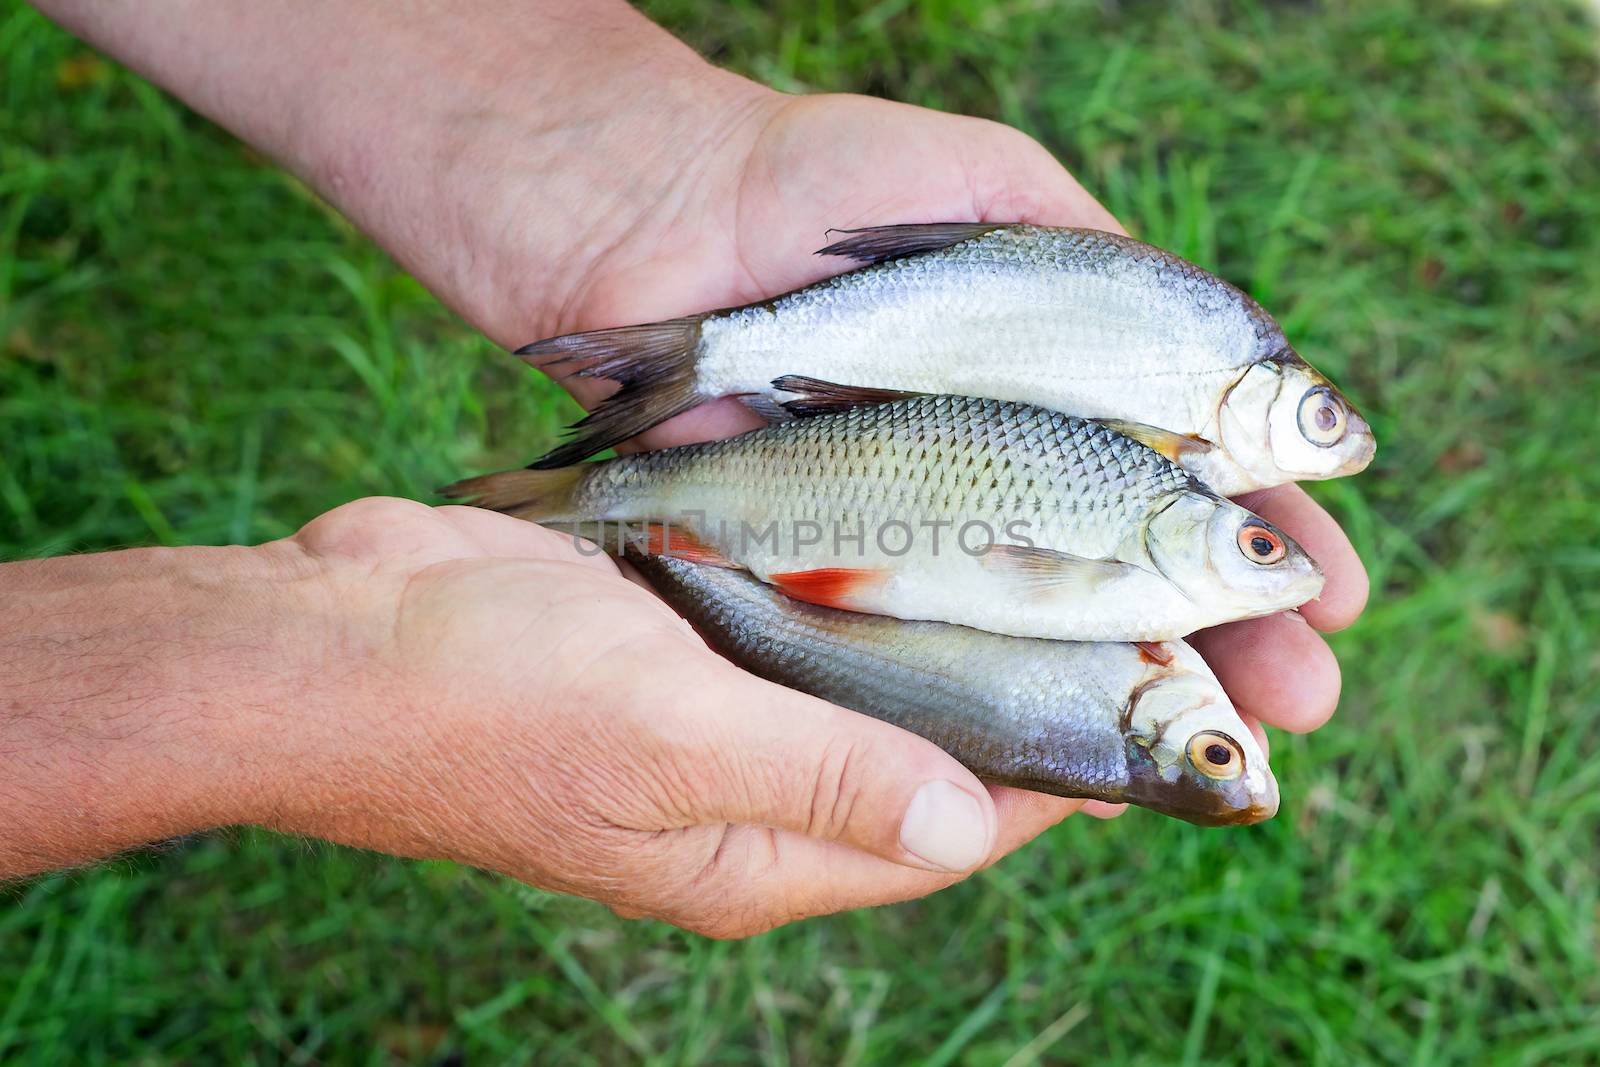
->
xmin=1218 ymin=363 xmax=1378 ymax=486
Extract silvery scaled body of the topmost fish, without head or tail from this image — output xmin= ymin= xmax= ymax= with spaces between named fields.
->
xmin=699 ymin=226 xmax=1286 ymax=395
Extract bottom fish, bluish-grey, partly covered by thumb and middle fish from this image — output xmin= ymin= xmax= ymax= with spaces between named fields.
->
xmin=629 ymin=552 xmax=1278 ymax=825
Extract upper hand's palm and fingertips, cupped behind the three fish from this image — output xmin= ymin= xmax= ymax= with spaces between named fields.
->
xmin=473 ymin=93 xmax=1366 ymax=811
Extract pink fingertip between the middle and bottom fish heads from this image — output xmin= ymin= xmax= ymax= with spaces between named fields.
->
xmin=1189 ymin=611 xmax=1339 ymax=733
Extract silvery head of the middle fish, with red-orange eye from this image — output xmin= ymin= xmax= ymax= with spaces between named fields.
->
xmin=1146 ymin=490 xmax=1323 ymax=619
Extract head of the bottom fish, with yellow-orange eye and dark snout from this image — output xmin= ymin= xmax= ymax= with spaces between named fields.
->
xmin=1126 ymin=652 xmax=1278 ymax=825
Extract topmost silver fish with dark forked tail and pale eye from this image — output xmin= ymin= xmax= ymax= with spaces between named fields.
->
xmin=517 ymin=222 xmax=1376 ymax=496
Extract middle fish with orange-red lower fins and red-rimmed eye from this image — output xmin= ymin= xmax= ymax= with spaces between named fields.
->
xmin=443 ymin=395 xmax=1323 ymax=641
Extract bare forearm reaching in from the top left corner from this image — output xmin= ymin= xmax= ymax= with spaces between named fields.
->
xmin=38 ymin=0 xmax=770 ymax=344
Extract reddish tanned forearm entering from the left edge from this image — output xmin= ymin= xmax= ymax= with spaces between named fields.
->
xmin=0 ymin=542 xmax=323 ymax=878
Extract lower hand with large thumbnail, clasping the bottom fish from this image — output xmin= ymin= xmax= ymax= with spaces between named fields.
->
xmin=268 ymin=499 xmax=1075 ymax=936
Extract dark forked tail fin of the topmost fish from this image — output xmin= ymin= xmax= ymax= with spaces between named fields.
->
xmin=517 ymin=315 xmax=704 ymax=470
